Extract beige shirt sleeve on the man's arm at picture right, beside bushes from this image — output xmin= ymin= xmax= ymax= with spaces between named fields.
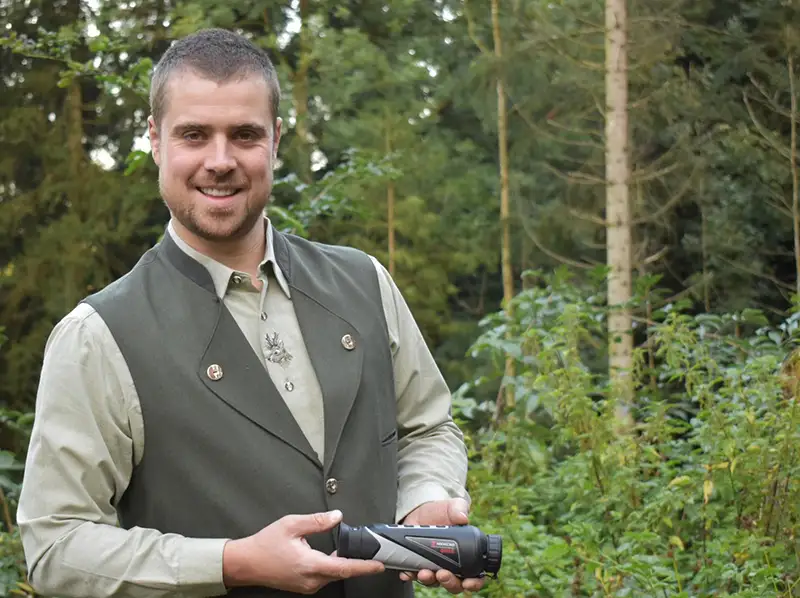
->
xmin=372 ymin=257 xmax=470 ymax=522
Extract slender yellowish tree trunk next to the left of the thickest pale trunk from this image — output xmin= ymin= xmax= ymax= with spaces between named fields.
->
xmin=492 ymin=0 xmax=515 ymax=417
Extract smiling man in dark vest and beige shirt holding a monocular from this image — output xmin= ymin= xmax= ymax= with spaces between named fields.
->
xmin=18 ymin=30 xmax=483 ymax=598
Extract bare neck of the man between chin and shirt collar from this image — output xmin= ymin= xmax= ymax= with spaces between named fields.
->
xmin=172 ymin=218 xmax=266 ymax=280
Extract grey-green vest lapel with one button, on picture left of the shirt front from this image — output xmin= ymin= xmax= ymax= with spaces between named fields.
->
xmin=162 ymin=233 xmax=327 ymax=466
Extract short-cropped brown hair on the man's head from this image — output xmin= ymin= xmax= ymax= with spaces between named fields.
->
xmin=150 ymin=28 xmax=281 ymax=126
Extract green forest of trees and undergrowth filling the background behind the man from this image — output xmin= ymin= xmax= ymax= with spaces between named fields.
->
xmin=0 ymin=0 xmax=800 ymax=597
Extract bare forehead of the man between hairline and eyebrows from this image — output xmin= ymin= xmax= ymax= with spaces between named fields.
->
xmin=163 ymin=71 xmax=271 ymax=126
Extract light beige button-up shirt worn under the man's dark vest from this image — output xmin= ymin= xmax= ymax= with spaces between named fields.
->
xmin=17 ymin=221 xmax=469 ymax=598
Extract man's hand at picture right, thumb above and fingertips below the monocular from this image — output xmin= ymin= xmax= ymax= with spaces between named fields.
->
xmin=400 ymin=498 xmax=486 ymax=594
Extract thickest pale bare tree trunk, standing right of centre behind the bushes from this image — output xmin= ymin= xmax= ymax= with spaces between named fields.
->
xmin=606 ymin=0 xmax=633 ymax=404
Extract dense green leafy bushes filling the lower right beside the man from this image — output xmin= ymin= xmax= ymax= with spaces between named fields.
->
xmin=432 ymin=271 xmax=800 ymax=597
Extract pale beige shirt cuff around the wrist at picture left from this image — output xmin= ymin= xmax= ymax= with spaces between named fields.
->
xmin=178 ymin=538 xmax=228 ymax=596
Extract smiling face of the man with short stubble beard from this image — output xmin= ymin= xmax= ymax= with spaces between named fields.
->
xmin=149 ymin=71 xmax=281 ymax=242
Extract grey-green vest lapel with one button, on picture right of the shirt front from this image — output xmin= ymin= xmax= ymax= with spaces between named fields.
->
xmin=273 ymin=230 xmax=364 ymax=473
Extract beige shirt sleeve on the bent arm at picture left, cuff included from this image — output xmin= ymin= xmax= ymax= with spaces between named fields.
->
xmin=17 ymin=304 xmax=226 ymax=598
